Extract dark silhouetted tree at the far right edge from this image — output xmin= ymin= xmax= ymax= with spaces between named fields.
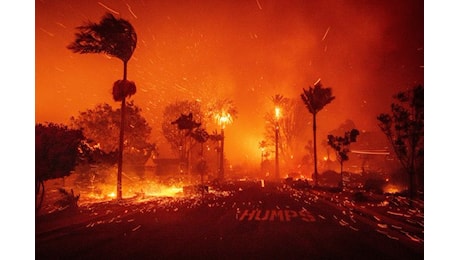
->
xmin=377 ymin=85 xmax=424 ymax=205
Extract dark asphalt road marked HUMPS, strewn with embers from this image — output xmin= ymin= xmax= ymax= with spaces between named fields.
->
xmin=35 ymin=183 xmax=424 ymax=259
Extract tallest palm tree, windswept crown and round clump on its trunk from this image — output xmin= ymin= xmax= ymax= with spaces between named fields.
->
xmin=67 ymin=13 xmax=137 ymax=200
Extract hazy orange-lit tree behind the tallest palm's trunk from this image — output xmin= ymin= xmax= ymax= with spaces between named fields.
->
xmin=70 ymin=101 xmax=158 ymax=177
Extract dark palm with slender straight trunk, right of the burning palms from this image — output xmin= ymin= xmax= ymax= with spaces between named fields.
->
xmin=300 ymin=80 xmax=335 ymax=186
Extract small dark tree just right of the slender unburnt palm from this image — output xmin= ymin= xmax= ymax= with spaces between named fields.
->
xmin=327 ymin=129 xmax=359 ymax=188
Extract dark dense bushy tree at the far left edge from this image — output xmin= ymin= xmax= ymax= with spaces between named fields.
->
xmin=35 ymin=123 xmax=84 ymax=210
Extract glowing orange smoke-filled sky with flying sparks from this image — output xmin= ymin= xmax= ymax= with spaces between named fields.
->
xmin=35 ymin=0 xmax=424 ymax=165
